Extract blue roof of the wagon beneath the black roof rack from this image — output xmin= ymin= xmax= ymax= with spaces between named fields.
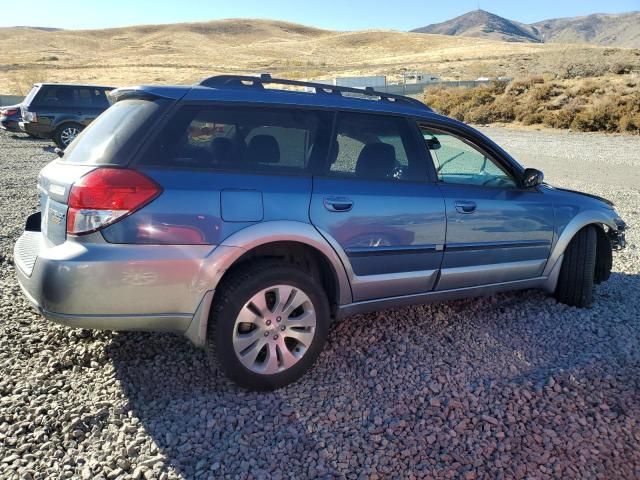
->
xmin=110 ymin=85 xmax=442 ymax=119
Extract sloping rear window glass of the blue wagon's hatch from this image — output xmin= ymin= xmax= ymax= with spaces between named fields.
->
xmin=62 ymin=99 xmax=169 ymax=165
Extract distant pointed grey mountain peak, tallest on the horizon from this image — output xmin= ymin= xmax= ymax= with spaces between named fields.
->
xmin=412 ymin=10 xmax=541 ymax=43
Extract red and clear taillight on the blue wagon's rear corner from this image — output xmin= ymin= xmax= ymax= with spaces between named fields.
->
xmin=67 ymin=168 xmax=162 ymax=235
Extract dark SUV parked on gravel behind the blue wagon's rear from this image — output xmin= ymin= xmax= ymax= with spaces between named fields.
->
xmin=20 ymin=83 xmax=113 ymax=149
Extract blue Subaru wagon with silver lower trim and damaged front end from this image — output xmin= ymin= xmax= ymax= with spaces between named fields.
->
xmin=15 ymin=75 xmax=625 ymax=389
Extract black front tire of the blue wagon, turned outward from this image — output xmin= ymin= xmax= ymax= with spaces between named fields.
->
xmin=555 ymin=226 xmax=598 ymax=308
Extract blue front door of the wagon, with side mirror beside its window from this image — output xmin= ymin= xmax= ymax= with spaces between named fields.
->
xmin=420 ymin=125 xmax=554 ymax=290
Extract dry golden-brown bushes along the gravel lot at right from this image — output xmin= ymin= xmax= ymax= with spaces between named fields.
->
xmin=424 ymin=74 xmax=640 ymax=133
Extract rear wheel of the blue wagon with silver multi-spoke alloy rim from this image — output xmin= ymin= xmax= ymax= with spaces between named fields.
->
xmin=207 ymin=260 xmax=330 ymax=390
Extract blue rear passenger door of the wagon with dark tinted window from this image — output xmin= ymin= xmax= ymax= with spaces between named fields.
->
xmin=310 ymin=113 xmax=446 ymax=301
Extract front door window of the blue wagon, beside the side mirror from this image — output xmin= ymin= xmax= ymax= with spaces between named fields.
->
xmin=421 ymin=128 xmax=517 ymax=188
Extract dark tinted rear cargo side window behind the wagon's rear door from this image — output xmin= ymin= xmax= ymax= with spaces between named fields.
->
xmin=143 ymin=106 xmax=330 ymax=173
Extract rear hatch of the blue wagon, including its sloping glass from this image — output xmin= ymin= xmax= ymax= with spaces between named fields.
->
xmin=38 ymin=98 xmax=169 ymax=245
